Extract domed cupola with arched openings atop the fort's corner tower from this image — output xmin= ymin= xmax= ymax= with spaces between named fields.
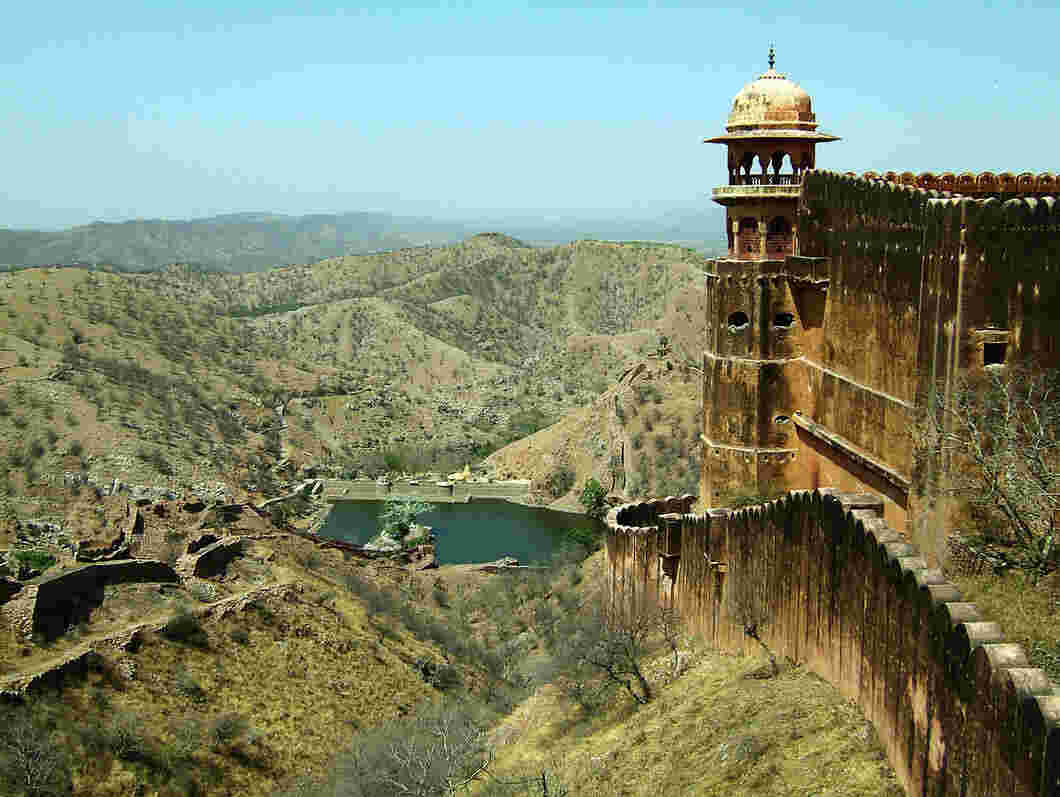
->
xmin=705 ymin=47 xmax=838 ymax=260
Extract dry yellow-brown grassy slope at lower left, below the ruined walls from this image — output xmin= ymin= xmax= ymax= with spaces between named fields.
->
xmin=11 ymin=538 xmax=451 ymax=797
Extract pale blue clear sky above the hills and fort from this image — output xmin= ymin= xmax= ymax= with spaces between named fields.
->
xmin=0 ymin=0 xmax=1060 ymax=229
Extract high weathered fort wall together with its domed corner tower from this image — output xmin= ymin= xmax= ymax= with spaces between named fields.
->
xmin=701 ymin=51 xmax=1060 ymax=565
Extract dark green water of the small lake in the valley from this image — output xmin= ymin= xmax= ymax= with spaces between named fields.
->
xmin=320 ymin=499 xmax=602 ymax=565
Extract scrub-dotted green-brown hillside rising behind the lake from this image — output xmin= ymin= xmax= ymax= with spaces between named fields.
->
xmin=0 ymin=234 xmax=704 ymax=534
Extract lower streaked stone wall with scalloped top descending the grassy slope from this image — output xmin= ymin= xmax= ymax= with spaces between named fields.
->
xmin=606 ymin=491 xmax=1060 ymax=797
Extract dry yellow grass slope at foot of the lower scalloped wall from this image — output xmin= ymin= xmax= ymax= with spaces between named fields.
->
xmin=485 ymin=653 xmax=902 ymax=797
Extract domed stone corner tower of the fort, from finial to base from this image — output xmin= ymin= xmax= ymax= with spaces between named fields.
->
xmin=700 ymin=48 xmax=838 ymax=508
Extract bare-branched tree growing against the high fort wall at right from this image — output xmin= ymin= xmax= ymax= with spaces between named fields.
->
xmin=917 ymin=366 xmax=1060 ymax=581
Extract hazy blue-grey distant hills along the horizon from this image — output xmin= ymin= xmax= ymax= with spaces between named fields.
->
xmin=0 ymin=209 xmax=722 ymax=272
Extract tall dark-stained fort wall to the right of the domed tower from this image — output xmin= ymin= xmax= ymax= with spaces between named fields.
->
xmin=780 ymin=172 xmax=1060 ymax=564
